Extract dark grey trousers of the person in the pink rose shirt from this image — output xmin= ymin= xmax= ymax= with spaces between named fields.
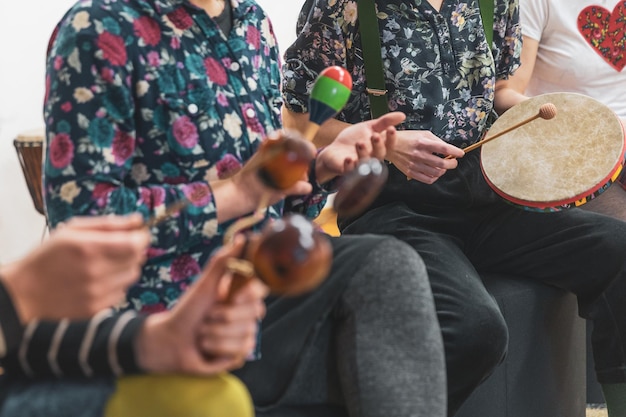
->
xmin=235 ymin=235 xmax=446 ymax=417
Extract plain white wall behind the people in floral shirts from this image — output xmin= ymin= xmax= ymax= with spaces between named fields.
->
xmin=0 ymin=0 xmax=302 ymax=262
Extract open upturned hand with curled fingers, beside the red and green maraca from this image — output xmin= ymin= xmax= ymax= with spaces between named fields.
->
xmin=315 ymin=112 xmax=405 ymax=184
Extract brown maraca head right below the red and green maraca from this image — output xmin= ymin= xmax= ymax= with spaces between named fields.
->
xmin=258 ymin=130 xmax=315 ymax=190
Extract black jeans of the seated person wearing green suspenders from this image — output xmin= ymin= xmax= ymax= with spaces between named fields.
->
xmin=340 ymin=152 xmax=626 ymax=415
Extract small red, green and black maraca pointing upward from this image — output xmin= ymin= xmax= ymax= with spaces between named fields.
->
xmin=302 ymin=65 xmax=352 ymax=140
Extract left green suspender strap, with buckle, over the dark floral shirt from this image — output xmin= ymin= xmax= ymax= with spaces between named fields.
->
xmin=357 ymin=0 xmax=389 ymax=118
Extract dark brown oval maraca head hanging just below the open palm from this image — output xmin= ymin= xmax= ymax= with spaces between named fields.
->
xmin=333 ymin=158 xmax=389 ymax=217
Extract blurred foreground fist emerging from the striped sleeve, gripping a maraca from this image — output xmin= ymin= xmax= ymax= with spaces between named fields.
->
xmin=136 ymin=236 xmax=268 ymax=375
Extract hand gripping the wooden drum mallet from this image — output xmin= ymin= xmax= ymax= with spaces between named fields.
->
xmin=387 ymin=130 xmax=465 ymax=184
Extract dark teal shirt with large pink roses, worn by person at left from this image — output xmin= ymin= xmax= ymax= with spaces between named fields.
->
xmin=44 ymin=0 xmax=325 ymax=312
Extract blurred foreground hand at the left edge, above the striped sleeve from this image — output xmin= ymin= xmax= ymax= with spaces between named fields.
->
xmin=0 ymin=214 xmax=150 ymax=323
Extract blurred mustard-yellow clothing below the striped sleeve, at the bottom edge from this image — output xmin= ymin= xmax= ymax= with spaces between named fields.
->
xmin=104 ymin=374 xmax=254 ymax=417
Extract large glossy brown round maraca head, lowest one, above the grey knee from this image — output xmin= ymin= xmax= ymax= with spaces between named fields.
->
xmin=244 ymin=214 xmax=332 ymax=296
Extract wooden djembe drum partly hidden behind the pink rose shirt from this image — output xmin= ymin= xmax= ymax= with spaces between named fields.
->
xmin=13 ymin=129 xmax=45 ymax=216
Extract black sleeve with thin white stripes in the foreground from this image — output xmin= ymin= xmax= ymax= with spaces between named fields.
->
xmin=3 ymin=310 xmax=144 ymax=378
